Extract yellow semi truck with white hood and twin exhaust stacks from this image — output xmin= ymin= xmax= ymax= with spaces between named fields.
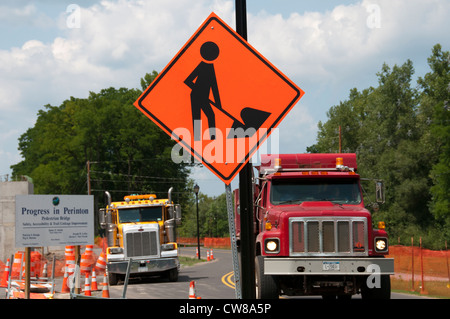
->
xmin=99 ymin=187 xmax=181 ymax=285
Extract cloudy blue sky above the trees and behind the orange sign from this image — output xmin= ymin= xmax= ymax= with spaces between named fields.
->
xmin=0 ymin=0 xmax=450 ymax=195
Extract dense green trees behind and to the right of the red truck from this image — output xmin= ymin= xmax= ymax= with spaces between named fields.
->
xmin=307 ymin=45 xmax=450 ymax=248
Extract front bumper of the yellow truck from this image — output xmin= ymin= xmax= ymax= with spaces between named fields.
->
xmin=107 ymin=257 xmax=180 ymax=274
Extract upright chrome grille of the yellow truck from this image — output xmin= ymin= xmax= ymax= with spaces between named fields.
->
xmin=125 ymin=231 xmax=158 ymax=257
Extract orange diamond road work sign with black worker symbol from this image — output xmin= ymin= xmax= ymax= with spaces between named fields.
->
xmin=134 ymin=13 xmax=304 ymax=184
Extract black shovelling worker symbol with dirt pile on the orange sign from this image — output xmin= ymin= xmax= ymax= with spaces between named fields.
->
xmin=184 ymin=41 xmax=271 ymax=141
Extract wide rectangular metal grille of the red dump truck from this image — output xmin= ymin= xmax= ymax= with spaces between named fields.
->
xmin=289 ymin=217 xmax=368 ymax=256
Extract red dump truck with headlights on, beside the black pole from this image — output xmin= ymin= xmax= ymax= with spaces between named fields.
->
xmin=234 ymin=153 xmax=394 ymax=299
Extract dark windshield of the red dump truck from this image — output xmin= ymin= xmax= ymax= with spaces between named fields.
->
xmin=270 ymin=179 xmax=361 ymax=205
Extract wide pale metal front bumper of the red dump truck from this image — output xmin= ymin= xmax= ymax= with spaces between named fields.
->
xmin=264 ymin=257 xmax=394 ymax=275
